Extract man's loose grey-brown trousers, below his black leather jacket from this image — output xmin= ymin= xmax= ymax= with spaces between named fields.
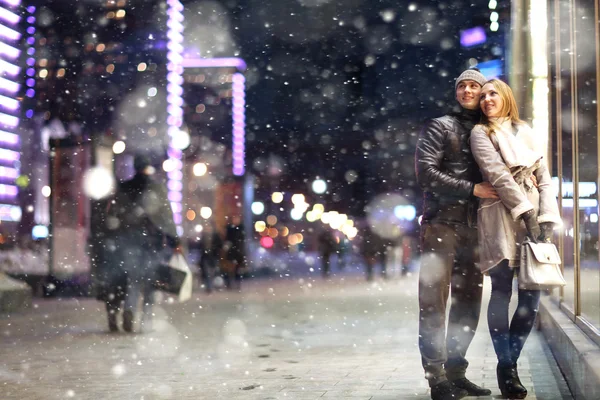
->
xmin=419 ymin=223 xmax=483 ymax=387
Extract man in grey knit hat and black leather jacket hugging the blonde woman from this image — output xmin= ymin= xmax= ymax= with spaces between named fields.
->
xmin=415 ymin=69 xmax=497 ymax=400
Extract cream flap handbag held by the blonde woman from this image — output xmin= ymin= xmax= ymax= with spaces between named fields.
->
xmin=519 ymin=240 xmax=567 ymax=290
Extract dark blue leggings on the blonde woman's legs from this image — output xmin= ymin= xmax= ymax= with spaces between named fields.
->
xmin=488 ymin=261 xmax=540 ymax=366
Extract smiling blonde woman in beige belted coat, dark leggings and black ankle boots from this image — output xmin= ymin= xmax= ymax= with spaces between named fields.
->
xmin=470 ymin=79 xmax=560 ymax=399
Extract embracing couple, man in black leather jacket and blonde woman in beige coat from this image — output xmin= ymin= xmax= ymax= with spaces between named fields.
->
xmin=415 ymin=69 xmax=560 ymax=400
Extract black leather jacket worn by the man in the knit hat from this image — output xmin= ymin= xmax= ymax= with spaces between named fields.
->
xmin=415 ymin=109 xmax=482 ymax=226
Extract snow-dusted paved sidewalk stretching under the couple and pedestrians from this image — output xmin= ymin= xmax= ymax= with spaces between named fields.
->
xmin=0 ymin=275 xmax=571 ymax=400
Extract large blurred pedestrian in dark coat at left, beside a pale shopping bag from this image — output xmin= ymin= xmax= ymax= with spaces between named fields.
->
xmin=106 ymin=155 xmax=179 ymax=332
